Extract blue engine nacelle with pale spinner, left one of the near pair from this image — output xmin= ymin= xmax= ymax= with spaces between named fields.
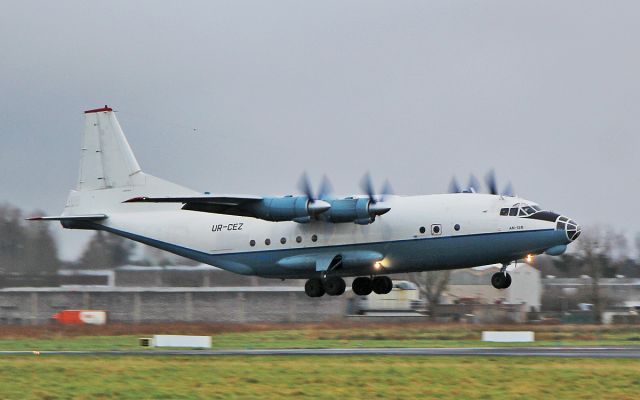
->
xmin=250 ymin=196 xmax=331 ymax=222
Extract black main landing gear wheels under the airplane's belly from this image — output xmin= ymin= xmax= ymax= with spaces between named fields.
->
xmin=304 ymin=276 xmax=393 ymax=297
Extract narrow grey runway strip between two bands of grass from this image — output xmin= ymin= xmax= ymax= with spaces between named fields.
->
xmin=0 ymin=346 xmax=640 ymax=358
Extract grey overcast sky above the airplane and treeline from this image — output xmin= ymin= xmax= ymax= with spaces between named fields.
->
xmin=0 ymin=0 xmax=640 ymax=258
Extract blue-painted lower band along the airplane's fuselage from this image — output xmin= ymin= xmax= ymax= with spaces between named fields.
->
xmin=90 ymin=222 xmax=566 ymax=278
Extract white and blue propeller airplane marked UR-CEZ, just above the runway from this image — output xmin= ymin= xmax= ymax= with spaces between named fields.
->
xmin=30 ymin=106 xmax=581 ymax=297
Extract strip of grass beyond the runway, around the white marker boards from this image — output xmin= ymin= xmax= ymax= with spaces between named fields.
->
xmin=0 ymin=324 xmax=640 ymax=351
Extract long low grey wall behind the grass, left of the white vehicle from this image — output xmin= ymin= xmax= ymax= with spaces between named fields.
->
xmin=0 ymin=287 xmax=347 ymax=325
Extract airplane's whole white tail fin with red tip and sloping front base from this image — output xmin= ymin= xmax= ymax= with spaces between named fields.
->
xmin=63 ymin=106 xmax=196 ymax=215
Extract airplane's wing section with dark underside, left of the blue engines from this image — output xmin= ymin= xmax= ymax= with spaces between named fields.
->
xmin=125 ymin=195 xmax=263 ymax=217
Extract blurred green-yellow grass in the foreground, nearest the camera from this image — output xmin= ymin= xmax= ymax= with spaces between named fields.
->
xmin=0 ymin=356 xmax=640 ymax=400
